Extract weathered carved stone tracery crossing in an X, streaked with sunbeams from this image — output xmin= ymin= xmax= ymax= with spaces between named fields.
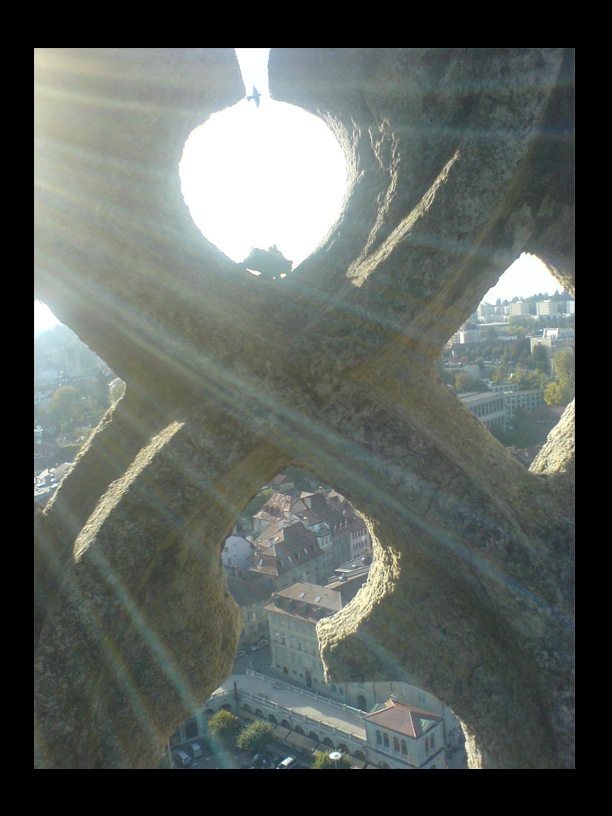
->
xmin=35 ymin=48 xmax=574 ymax=769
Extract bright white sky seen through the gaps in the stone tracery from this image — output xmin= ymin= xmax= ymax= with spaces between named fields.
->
xmin=34 ymin=48 xmax=561 ymax=330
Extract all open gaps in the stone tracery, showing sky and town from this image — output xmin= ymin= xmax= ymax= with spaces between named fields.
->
xmin=34 ymin=49 xmax=575 ymax=769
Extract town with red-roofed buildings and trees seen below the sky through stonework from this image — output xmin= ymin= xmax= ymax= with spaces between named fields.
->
xmin=34 ymin=293 xmax=575 ymax=770
